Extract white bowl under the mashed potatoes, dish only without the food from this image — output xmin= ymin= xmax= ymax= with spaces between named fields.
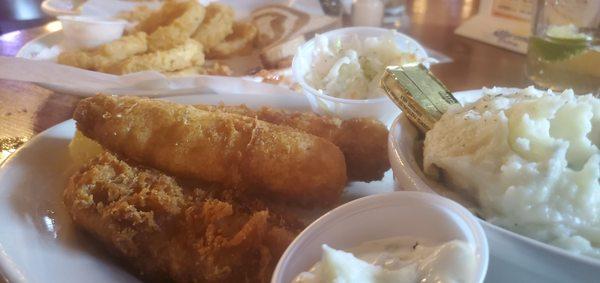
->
xmin=389 ymin=90 xmax=600 ymax=282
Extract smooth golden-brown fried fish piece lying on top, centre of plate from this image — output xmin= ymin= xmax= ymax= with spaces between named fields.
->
xmin=73 ymin=95 xmax=347 ymax=205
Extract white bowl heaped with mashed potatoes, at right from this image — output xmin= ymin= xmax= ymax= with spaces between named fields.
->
xmin=389 ymin=87 xmax=600 ymax=282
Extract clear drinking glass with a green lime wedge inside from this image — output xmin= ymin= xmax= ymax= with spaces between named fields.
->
xmin=527 ymin=0 xmax=600 ymax=95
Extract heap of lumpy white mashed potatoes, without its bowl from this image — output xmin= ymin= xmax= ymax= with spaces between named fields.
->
xmin=423 ymin=87 xmax=600 ymax=258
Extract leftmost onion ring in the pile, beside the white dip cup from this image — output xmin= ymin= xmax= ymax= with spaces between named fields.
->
xmin=58 ymin=32 xmax=148 ymax=70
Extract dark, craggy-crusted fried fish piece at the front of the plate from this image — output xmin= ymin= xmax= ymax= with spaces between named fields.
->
xmin=64 ymin=153 xmax=300 ymax=282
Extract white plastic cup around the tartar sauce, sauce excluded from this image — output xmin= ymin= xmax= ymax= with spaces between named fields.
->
xmin=271 ymin=192 xmax=489 ymax=283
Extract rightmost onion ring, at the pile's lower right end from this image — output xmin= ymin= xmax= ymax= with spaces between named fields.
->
xmin=206 ymin=23 xmax=258 ymax=59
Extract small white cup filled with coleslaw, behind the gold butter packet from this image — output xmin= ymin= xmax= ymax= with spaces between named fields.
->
xmin=292 ymin=27 xmax=429 ymax=123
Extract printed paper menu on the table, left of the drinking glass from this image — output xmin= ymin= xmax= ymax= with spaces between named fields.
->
xmin=454 ymin=0 xmax=535 ymax=54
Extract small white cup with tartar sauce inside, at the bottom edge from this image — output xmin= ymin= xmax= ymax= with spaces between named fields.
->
xmin=271 ymin=192 xmax=489 ymax=283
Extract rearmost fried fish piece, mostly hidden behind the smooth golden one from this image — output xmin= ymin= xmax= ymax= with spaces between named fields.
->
xmin=195 ymin=105 xmax=390 ymax=181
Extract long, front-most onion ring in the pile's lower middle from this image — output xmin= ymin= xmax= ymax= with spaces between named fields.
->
xmin=102 ymin=39 xmax=204 ymax=75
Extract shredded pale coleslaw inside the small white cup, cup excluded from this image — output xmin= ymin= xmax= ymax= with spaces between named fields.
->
xmin=305 ymin=30 xmax=417 ymax=99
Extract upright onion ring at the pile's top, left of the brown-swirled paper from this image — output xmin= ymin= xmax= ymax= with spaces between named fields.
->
xmin=192 ymin=3 xmax=234 ymax=52
